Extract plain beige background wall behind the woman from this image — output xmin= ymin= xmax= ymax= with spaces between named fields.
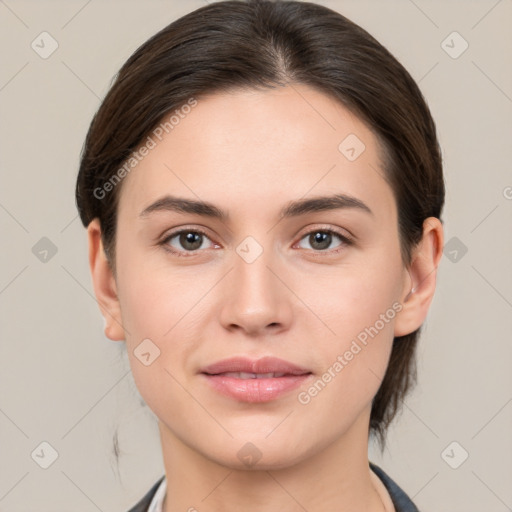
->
xmin=0 ymin=0 xmax=512 ymax=512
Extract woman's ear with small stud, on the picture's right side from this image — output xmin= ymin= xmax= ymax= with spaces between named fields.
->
xmin=394 ymin=217 xmax=444 ymax=336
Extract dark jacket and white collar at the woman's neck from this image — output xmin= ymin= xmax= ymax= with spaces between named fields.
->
xmin=128 ymin=462 xmax=419 ymax=512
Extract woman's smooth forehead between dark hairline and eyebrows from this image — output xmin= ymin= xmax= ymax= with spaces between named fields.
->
xmin=119 ymin=85 xmax=395 ymax=224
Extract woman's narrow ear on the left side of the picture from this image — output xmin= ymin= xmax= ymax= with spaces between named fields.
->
xmin=87 ymin=218 xmax=125 ymax=341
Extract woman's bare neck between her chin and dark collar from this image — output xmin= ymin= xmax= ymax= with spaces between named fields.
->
xmin=159 ymin=408 xmax=384 ymax=512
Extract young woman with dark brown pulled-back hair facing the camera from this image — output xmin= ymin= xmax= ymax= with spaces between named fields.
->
xmin=76 ymin=0 xmax=444 ymax=512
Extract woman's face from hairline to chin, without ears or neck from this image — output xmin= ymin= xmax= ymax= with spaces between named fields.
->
xmin=107 ymin=85 xmax=411 ymax=468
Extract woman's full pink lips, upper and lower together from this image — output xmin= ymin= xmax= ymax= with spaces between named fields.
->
xmin=201 ymin=357 xmax=312 ymax=403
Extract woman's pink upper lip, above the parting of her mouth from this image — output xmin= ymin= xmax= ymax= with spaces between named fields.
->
xmin=201 ymin=356 xmax=311 ymax=375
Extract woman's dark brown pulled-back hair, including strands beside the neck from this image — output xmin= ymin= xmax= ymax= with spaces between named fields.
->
xmin=76 ymin=0 xmax=444 ymax=449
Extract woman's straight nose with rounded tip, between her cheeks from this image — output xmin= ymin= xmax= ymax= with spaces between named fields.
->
xmin=220 ymin=243 xmax=293 ymax=336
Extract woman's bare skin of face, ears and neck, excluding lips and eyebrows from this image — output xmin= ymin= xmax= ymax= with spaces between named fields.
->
xmin=88 ymin=84 xmax=443 ymax=512
